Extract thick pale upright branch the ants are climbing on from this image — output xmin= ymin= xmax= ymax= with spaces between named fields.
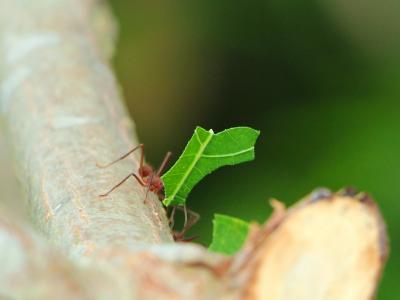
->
xmin=0 ymin=0 xmax=172 ymax=253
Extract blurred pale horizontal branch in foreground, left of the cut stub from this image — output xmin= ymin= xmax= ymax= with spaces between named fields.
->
xmin=0 ymin=206 xmax=228 ymax=300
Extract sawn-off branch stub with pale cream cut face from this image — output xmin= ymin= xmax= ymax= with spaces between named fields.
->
xmin=231 ymin=189 xmax=388 ymax=300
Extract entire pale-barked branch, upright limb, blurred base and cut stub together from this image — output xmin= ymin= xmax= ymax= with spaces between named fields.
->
xmin=0 ymin=0 xmax=387 ymax=300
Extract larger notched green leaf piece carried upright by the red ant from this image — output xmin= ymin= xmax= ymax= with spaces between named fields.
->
xmin=161 ymin=127 xmax=260 ymax=206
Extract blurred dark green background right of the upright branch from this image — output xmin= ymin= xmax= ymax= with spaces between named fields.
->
xmin=111 ymin=0 xmax=400 ymax=299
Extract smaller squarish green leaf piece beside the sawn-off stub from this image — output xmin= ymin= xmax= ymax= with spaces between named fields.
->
xmin=209 ymin=214 xmax=250 ymax=255
